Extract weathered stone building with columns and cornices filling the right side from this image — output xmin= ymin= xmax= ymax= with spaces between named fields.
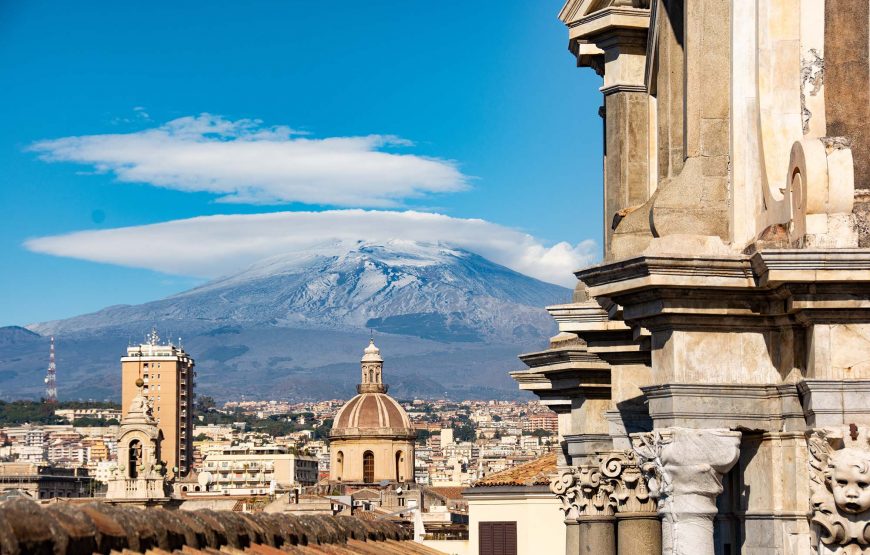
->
xmin=513 ymin=0 xmax=870 ymax=555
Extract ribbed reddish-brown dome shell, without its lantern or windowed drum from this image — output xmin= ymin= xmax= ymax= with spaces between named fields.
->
xmin=332 ymin=393 xmax=414 ymax=436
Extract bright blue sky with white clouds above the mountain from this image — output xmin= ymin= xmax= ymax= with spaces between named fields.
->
xmin=0 ymin=0 xmax=601 ymax=325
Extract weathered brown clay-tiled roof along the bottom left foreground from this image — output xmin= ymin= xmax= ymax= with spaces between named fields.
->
xmin=0 ymin=499 xmax=440 ymax=555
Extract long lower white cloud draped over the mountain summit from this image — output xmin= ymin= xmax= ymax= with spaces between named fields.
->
xmin=25 ymin=210 xmax=597 ymax=287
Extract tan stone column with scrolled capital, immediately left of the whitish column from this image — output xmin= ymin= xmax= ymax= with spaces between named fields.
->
xmin=599 ymin=451 xmax=662 ymax=555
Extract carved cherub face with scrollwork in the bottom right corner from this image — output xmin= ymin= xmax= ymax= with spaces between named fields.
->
xmin=807 ymin=425 xmax=870 ymax=555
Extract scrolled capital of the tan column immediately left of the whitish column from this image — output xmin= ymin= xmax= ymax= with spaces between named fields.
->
xmin=599 ymin=451 xmax=656 ymax=514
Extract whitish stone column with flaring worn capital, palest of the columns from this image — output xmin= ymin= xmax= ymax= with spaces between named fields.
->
xmin=632 ymin=428 xmax=741 ymax=555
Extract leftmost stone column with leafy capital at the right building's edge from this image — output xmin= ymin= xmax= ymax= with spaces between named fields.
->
xmin=550 ymin=465 xmax=616 ymax=555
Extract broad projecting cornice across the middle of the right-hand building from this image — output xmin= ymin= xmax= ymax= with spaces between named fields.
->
xmin=572 ymin=253 xmax=870 ymax=334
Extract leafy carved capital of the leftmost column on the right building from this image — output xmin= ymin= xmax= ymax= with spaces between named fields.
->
xmin=550 ymin=465 xmax=614 ymax=519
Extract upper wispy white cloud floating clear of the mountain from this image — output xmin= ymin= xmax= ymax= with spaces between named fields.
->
xmin=30 ymin=114 xmax=468 ymax=208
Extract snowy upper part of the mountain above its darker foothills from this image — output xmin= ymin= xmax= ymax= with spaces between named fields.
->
xmin=29 ymin=240 xmax=569 ymax=341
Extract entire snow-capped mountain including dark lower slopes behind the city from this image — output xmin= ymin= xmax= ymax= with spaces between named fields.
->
xmin=0 ymin=241 xmax=570 ymax=399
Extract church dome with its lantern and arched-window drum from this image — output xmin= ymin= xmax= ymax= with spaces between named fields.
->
xmin=329 ymin=341 xmax=417 ymax=484
